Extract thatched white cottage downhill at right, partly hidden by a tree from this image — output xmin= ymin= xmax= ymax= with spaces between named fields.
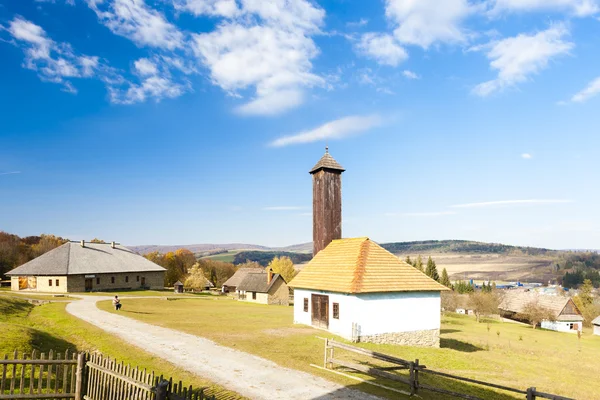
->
xmin=498 ymin=290 xmax=583 ymax=333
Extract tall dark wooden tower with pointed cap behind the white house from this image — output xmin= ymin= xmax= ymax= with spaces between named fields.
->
xmin=310 ymin=147 xmax=345 ymax=256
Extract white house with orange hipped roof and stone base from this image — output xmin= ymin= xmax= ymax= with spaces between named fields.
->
xmin=289 ymin=237 xmax=448 ymax=347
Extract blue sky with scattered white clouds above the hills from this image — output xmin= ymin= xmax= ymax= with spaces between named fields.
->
xmin=0 ymin=0 xmax=600 ymax=248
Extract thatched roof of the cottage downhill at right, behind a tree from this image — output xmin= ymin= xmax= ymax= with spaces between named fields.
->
xmin=498 ymin=290 xmax=583 ymax=321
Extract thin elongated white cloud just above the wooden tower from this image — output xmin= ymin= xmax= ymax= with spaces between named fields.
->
xmin=270 ymin=115 xmax=383 ymax=147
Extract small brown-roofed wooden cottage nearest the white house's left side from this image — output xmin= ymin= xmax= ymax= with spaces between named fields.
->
xmin=237 ymin=270 xmax=290 ymax=306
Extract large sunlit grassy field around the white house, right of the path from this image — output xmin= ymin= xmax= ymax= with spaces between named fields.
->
xmin=99 ymin=298 xmax=600 ymax=399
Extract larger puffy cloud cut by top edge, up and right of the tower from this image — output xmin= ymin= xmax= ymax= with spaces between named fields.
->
xmin=385 ymin=0 xmax=477 ymax=49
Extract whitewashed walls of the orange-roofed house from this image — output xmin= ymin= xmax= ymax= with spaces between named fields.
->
xmin=294 ymin=289 xmax=441 ymax=339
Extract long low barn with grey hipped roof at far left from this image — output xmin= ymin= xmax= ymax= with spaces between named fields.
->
xmin=6 ymin=240 xmax=165 ymax=293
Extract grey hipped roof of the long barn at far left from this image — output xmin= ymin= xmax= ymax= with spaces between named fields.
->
xmin=6 ymin=242 xmax=165 ymax=276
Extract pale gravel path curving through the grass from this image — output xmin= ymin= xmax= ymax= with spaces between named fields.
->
xmin=67 ymin=296 xmax=378 ymax=400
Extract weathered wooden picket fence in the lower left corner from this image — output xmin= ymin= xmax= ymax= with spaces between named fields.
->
xmin=0 ymin=351 xmax=215 ymax=400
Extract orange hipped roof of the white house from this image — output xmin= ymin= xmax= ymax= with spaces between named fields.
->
xmin=289 ymin=237 xmax=448 ymax=293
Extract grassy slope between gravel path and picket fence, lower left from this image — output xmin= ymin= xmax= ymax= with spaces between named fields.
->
xmin=0 ymin=296 xmax=243 ymax=400
